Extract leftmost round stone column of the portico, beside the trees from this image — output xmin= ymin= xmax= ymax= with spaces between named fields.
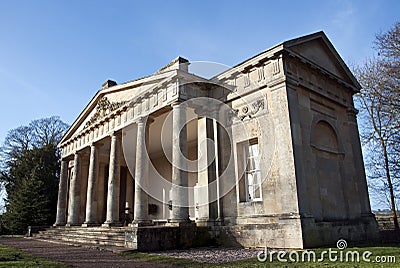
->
xmin=54 ymin=160 xmax=68 ymax=226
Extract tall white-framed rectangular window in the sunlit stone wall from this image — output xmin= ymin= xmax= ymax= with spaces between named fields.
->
xmin=243 ymin=139 xmax=262 ymax=201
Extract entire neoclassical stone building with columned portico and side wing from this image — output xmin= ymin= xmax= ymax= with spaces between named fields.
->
xmin=55 ymin=32 xmax=377 ymax=248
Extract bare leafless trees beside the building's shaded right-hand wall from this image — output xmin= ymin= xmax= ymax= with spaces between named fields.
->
xmin=355 ymin=23 xmax=400 ymax=229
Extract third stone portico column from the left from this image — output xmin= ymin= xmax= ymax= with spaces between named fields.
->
xmin=82 ymin=144 xmax=98 ymax=227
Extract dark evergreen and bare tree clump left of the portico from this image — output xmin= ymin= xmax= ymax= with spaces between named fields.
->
xmin=0 ymin=116 xmax=68 ymax=230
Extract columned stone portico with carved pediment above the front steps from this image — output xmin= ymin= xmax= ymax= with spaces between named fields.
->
xmin=55 ymin=59 xmax=214 ymax=227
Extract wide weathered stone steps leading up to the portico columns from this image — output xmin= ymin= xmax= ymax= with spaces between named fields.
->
xmin=33 ymin=227 xmax=125 ymax=248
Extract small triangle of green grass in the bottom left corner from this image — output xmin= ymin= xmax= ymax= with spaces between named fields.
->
xmin=0 ymin=244 xmax=70 ymax=268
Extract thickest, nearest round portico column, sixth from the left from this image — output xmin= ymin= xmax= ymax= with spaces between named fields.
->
xmin=170 ymin=103 xmax=189 ymax=223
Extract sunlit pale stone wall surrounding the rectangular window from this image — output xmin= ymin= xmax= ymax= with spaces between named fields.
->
xmin=213 ymin=56 xmax=303 ymax=248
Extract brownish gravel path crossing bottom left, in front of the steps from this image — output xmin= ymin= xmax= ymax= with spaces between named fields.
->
xmin=0 ymin=238 xmax=171 ymax=268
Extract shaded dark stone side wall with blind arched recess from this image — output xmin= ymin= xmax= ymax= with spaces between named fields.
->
xmin=286 ymin=50 xmax=377 ymax=247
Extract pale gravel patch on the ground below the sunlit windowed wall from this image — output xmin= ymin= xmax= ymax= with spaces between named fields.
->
xmin=153 ymin=248 xmax=259 ymax=263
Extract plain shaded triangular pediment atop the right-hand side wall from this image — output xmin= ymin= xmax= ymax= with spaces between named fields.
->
xmin=284 ymin=32 xmax=360 ymax=89
